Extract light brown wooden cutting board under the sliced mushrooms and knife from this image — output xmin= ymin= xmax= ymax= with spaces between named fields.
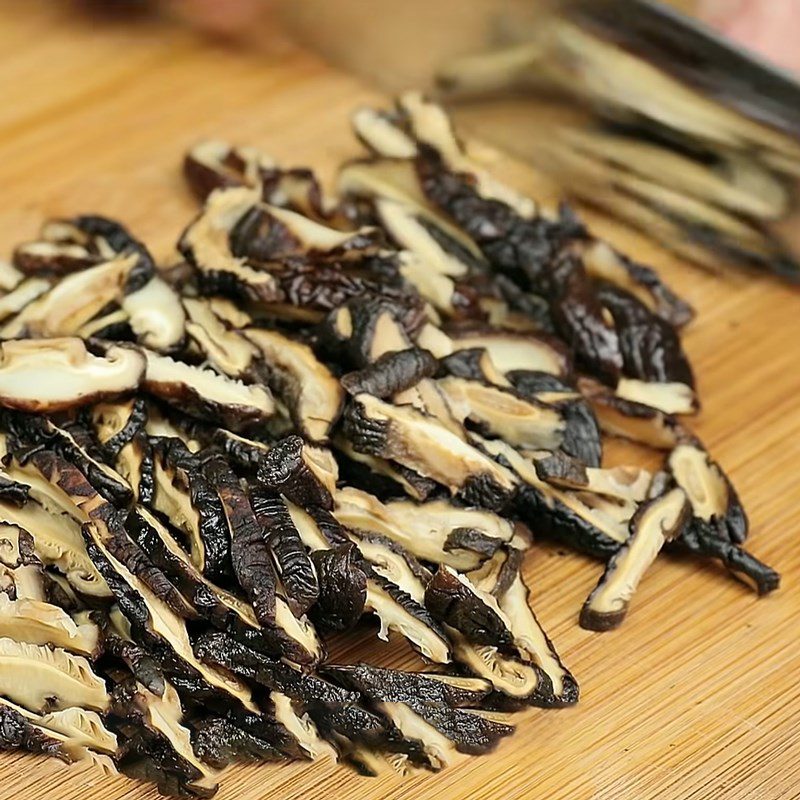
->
xmin=0 ymin=0 xmax=800 ymax=800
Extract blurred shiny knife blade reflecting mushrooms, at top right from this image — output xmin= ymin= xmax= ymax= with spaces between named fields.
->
xmin=283 ymin=0 xmax=800 ymax=282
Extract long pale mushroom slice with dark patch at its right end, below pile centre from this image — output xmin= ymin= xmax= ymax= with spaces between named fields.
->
xmin=334 ymin=487 xmax=514 ymax=571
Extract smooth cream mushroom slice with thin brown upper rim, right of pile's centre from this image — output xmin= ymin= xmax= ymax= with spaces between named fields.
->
xmin=447 ymin=325 xmax=571 ymax=377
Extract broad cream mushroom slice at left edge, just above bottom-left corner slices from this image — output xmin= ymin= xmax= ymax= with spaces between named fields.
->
xmin=0 ymin=637 xmax=109 ymax=712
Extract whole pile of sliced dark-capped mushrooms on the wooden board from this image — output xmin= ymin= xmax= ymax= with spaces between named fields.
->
xmin=0 ymin=94 xmax=778 ymax=797
